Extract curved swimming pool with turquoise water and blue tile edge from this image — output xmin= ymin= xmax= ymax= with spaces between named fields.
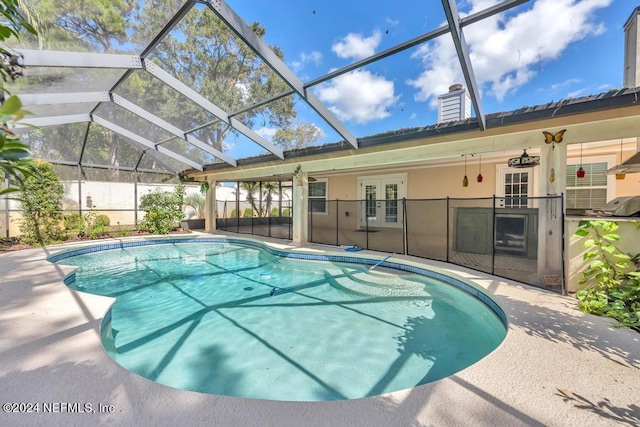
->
xmin=50 ymin=238 xmax=506 ymax=401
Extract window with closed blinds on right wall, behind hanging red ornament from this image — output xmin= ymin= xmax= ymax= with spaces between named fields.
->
xmin=567 ymin=162 xmax=607 ymax=210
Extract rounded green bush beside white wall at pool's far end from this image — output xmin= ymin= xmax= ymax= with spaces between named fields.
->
xmin=139 ymin=185 xmax=185 ymax=234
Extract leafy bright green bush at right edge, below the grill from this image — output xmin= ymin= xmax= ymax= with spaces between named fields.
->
xmin=575 ymin=220 xmax=640 ymax=332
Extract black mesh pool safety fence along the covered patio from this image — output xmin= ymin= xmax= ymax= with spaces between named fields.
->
xmin=309 ymin=196 xmax=565 ymax=294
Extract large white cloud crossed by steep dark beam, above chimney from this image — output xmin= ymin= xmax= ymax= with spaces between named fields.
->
xmin=407 ymin=0 xmax=613 ymax=108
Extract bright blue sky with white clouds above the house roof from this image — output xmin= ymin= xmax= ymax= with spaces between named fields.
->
xmin=221 ymin=0 xmax=638 ymax=157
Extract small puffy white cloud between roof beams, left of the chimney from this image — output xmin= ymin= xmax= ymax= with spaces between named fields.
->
xmin=317 ymin=70 xmax=400 ymax=124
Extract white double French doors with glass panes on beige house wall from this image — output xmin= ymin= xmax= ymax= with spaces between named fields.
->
xmin=359 ymin=176 xmax=404 ymax=227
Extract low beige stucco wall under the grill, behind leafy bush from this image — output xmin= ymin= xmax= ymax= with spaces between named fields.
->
xmin=565 ymin=218 xmax=640 ymax=292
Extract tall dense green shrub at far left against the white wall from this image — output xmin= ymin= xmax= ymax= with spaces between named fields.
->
xmin=20 ymin=160 xmax=65 ymax=246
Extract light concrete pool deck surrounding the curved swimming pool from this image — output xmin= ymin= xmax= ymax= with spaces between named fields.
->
xmin=0 ymin=233 xmax=640 ymax=427
